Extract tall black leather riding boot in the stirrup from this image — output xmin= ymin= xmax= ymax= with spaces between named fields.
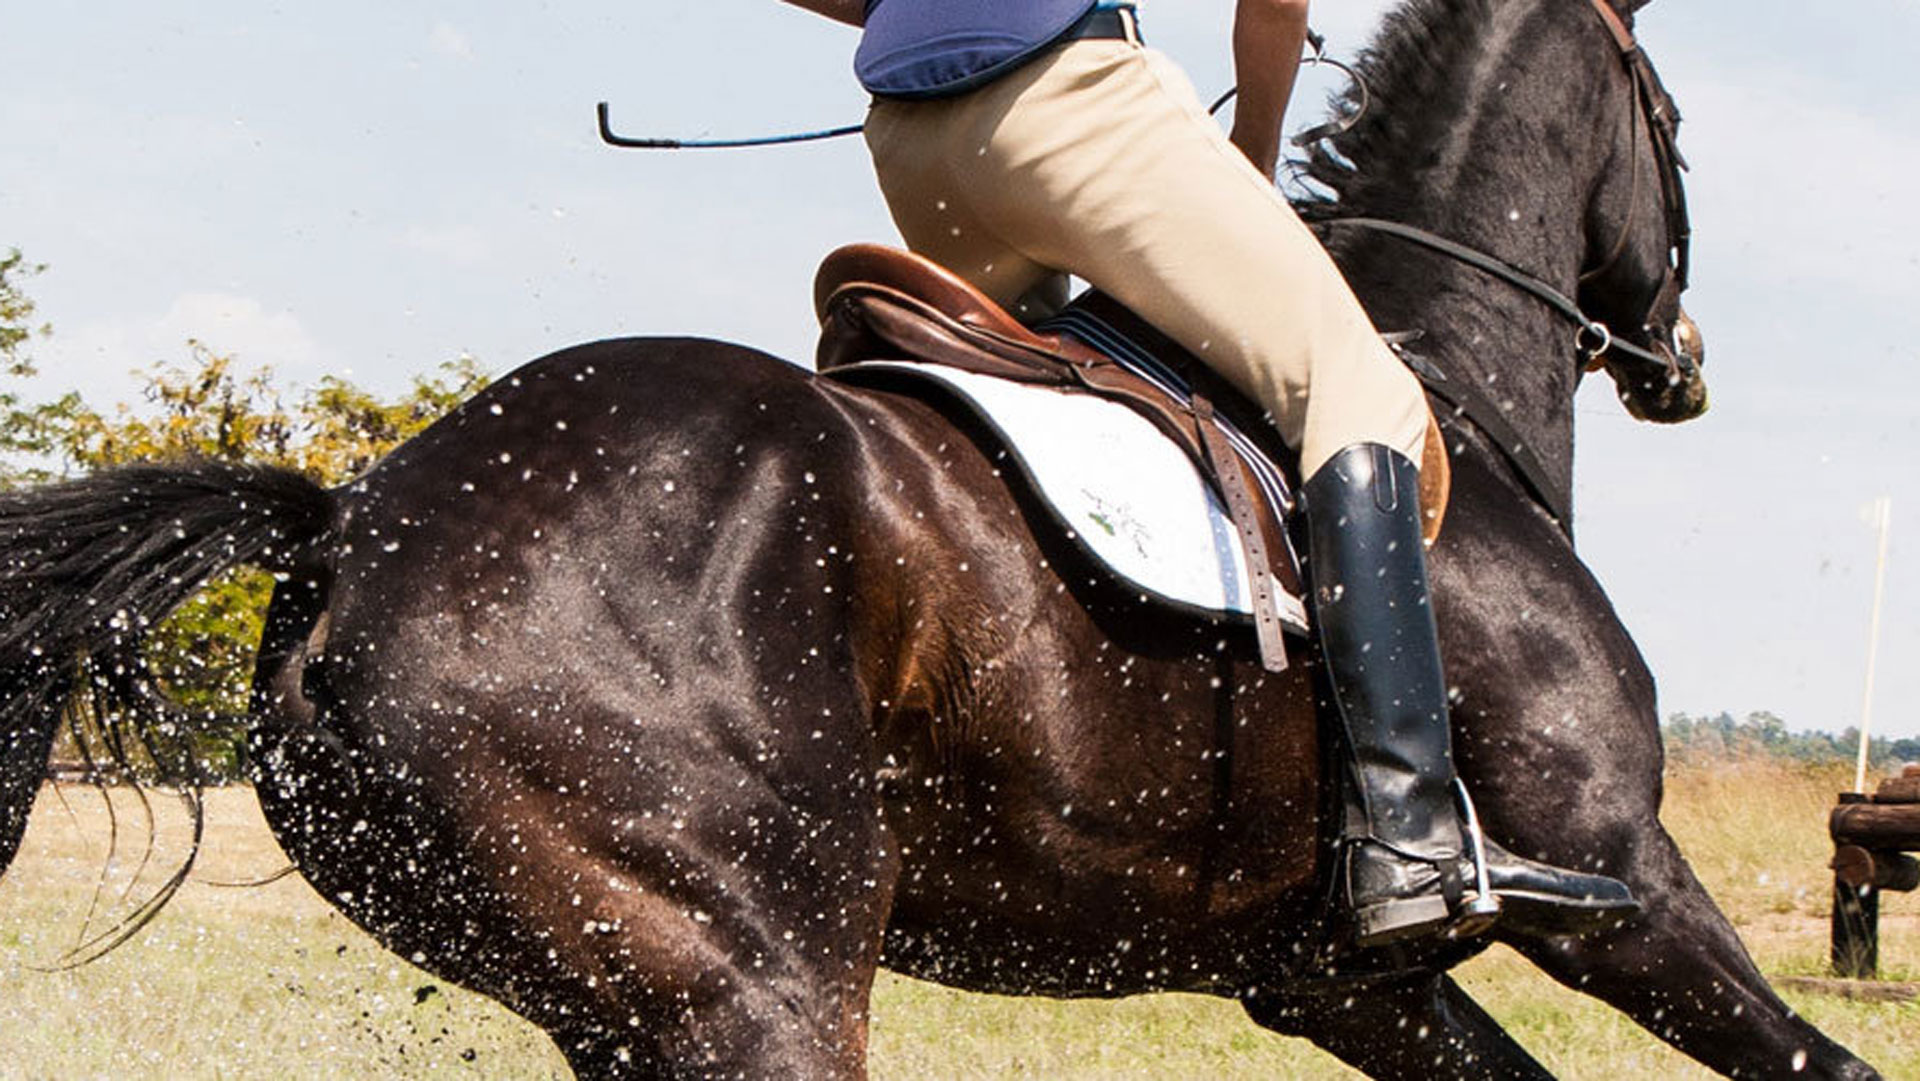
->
xmin=1302 ymin=444 xmax=1640 ymax=947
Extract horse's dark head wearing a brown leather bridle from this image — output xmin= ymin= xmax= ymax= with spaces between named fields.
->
xmin=1578 ymin=0 xmax=1707 ymax=424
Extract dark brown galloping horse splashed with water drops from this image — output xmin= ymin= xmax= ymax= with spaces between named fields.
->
xmin=0 ymin=0 xmax=1876 ymax=1079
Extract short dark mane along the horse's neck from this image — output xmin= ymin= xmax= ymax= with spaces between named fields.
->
xmin=1298 ymin=0 xmax=1494 ymax=219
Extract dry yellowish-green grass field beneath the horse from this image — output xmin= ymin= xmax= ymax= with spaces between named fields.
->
xmin=0 ymin=760 xmax=1920 ymax=1081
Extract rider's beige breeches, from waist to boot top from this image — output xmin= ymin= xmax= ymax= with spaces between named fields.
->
xmin=866 ymin=40 xmax=1428 ymax=476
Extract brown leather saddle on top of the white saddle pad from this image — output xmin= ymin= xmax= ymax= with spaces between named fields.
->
xmin=814 ymin=244 xmax=1302 ymax=672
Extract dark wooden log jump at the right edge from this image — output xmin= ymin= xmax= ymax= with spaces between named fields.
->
xmin=1826 ymin=766 xmax=1920 ymax=979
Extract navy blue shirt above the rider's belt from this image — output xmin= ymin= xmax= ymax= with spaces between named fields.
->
xmin=852 ymin=0 xmax=1096 ymax=98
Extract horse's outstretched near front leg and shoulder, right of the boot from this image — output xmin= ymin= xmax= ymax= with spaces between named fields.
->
xmin=1452 ymin=591 xmax=1876 ymax=1077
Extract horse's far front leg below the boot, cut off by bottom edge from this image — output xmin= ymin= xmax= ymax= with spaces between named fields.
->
xmin=1242 ymin=972 xmax=1553 ymax=1081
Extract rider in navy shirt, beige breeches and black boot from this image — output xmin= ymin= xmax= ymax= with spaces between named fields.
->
xmin=789 ymin=0 xmax=1638 ymax=947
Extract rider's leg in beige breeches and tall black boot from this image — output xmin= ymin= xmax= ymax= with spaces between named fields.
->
xmin=868 ymin=42 xmax=1632 ymax=943
